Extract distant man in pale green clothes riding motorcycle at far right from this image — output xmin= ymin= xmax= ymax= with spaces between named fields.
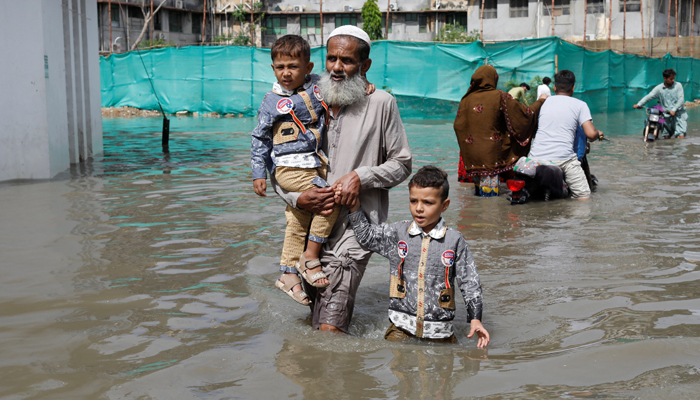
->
xmin=632 ymin=68 xmax=688 ymax=139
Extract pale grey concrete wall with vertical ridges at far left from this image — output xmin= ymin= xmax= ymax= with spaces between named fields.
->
xmin=0 ymin=0 xmax=102 ymax=181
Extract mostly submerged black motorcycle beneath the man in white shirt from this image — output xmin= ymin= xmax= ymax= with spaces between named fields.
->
xmin=506 ymin=127 xmax=608 ymax=205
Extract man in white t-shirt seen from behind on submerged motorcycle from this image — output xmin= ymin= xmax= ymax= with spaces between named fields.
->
xmin=529 ymin=69 xmax=603 ymax=199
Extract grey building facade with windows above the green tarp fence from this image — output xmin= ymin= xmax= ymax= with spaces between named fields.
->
xmin=97 ymin=0 xmax=700 ymax=52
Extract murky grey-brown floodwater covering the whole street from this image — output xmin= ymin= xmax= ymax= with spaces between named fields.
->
xmin=0 ymin=110 xmax=700 ymax=400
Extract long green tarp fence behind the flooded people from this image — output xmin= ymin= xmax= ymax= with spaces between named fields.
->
xmin=100 ymin=37 xmax=700 ymax=118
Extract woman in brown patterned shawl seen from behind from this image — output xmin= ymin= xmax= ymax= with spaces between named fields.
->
xmin=454 ymin=65 xmax=544 ymax=197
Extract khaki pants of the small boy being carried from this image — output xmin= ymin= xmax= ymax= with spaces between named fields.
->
xmin=275 ymin=165 xmax=340 ymax=268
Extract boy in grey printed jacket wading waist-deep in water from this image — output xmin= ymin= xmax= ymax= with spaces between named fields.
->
xmin=349 ymin=165 xmax=490 ymax=348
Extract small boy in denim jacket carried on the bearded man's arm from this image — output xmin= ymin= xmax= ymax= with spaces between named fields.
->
xmin=251 ymin=35 xmax=374 ymax=305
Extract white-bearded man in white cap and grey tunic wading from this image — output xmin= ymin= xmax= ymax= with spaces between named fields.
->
xmin=273 ymin=25 xmax=411 ymax=333
